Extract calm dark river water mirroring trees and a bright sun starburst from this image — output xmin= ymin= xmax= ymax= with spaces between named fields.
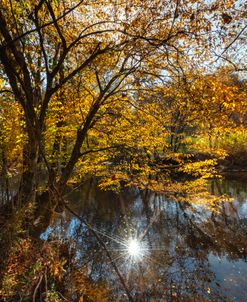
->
xmin=41 ymin=175 xmax=247 ymax=302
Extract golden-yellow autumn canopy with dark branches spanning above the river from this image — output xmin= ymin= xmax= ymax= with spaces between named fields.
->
xmin=0 ymin=0 xmax=246 ymax=203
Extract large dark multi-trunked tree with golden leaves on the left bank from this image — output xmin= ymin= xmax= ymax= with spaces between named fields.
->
xmin=0 ymin=0 xmax=243 ymax=203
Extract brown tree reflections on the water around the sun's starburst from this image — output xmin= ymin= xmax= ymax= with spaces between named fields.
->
xmin=40 ymin=180 xmax=247 ymax=302
